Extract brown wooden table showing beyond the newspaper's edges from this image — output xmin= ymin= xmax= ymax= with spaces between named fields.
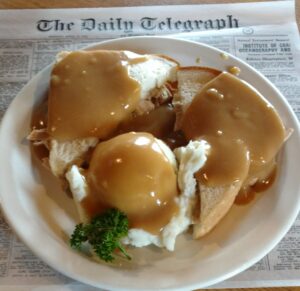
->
xmin=0 ymin=0 xmax=300 ymax=291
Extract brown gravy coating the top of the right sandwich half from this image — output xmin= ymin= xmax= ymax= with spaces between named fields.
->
xmin=182 ymin=72 xmax=285 ymax=196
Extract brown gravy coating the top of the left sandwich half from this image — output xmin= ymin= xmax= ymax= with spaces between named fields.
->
xmin=48 ymin=51 xmax=146 ymax=140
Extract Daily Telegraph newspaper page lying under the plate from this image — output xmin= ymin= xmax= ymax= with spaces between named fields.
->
xmin=0 ymin=1 xmax=300 ymax=291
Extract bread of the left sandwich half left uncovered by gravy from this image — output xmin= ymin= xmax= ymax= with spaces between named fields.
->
xmin=29 ymin=51 xmax=178 ymax=177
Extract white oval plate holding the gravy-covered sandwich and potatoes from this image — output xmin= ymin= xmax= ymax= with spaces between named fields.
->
xmin=0 ymin=37 xmax=300 ymax=290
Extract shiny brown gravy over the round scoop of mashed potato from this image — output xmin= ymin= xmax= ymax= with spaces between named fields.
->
xmin=82 ymin=133 xmax=178 ymax=233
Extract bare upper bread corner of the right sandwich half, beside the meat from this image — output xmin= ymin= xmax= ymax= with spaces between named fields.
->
xmin=172 ymin=67 xmax=221 ymax=130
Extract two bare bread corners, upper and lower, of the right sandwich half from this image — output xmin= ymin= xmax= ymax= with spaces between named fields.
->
xmin=174 ymin=67 xmax=242 ymax=238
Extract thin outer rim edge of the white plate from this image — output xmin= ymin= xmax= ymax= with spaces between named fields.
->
xmin=0 ymin=36 xmax=300 ymax=290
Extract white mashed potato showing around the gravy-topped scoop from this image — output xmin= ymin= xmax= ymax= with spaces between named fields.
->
xmin=66 ymin=139 xmax=209 ymax=251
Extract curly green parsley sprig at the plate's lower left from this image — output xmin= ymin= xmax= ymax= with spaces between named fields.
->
xmin=70 ymin=208 xmax=131 ymax=262
